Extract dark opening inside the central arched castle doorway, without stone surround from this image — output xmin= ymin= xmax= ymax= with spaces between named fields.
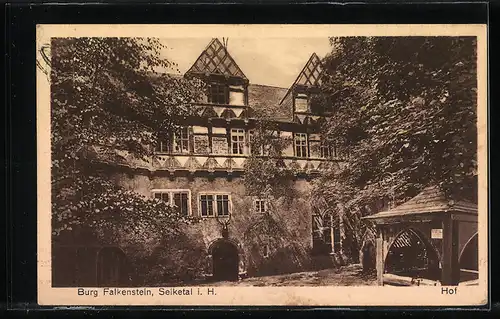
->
xmin=212 ymin=240 xmax=239 ymax=281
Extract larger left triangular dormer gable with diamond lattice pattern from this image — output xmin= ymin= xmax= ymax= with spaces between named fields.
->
xmin=186 ymin=38 xmax=248 ymax=80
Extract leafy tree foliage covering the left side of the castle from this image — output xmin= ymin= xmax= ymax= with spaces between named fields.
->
xmin=50 ymin=37 xmax=203 ymax=260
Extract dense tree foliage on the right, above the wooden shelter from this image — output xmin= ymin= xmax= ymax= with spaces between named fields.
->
xmin=316 ymin=37 xmax=477 ymax=222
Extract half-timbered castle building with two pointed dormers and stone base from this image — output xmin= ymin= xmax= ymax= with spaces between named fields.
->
xmin=52 ymin=39 xmax=346 ymax=288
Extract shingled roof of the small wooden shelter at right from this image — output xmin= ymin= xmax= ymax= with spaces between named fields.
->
xmin=363 ymin=186 xmax=477 ymax=220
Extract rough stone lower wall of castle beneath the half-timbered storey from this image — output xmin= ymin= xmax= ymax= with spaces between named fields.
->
xmin=111 ymin=173 xmax=335 ymax=276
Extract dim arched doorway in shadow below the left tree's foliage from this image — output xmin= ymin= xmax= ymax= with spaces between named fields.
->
xmin=97 ymin=247 xmax=129 ymax=287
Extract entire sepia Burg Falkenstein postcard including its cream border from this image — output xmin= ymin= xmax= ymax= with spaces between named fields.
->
xmin=36 ymin=25 xmax=488 ymax=305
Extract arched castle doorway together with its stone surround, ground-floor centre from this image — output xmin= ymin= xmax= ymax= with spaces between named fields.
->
xmin=208 ymin=238 xmax=245 ymax=281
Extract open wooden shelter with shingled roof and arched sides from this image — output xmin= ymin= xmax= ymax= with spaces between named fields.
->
xmin=363 ymin=186 xmax=478 ymax=285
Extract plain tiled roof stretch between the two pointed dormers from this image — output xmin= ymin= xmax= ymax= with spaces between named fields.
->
xmin=248 ymin=84 xmax=293 ymax=121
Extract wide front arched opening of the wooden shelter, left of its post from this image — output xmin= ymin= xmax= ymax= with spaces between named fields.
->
xmin=384 ymin=229 xmax=441 ymax=280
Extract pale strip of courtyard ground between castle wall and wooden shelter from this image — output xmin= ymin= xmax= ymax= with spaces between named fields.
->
xmin=198 ymin=265 xmax=376 ymax=287
